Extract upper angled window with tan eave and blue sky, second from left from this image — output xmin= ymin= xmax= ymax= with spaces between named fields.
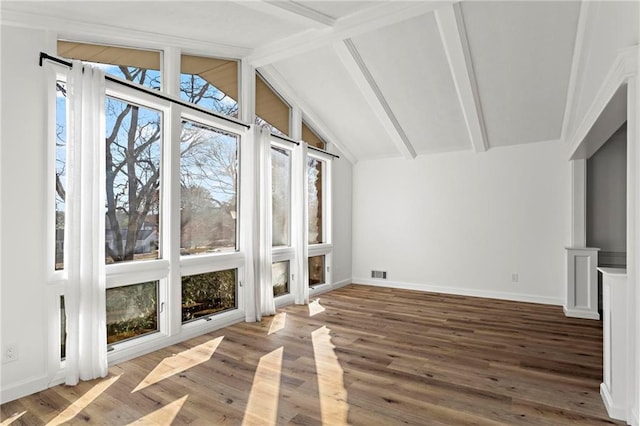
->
xmin=180 ymin=55 xmax=238 ymax=117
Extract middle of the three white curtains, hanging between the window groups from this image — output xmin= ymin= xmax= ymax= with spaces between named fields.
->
xmin=257 ymin=129 xmax=276 ymax=319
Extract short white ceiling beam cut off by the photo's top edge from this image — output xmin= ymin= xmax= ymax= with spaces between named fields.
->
xmin=234 ymin=0 xmax=335 ymax=29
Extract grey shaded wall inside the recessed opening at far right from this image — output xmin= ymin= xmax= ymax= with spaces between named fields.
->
xmin=587 ymin=126 xmax=627 ymax=253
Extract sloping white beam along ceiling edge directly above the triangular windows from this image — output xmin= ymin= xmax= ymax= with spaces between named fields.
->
xmin=260 ymin=65 xmax=358 ymax=164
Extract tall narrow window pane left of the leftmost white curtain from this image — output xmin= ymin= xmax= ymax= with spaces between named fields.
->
xmin=54 ymin=80 xmax=67 ymax=270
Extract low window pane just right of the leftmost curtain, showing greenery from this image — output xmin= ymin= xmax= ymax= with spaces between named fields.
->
xmin=106 ymin=281 xmax=158 ymax=344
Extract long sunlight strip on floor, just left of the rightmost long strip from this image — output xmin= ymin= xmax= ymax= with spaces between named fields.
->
xmin=242 ymin=346 xmax=284 ymax=426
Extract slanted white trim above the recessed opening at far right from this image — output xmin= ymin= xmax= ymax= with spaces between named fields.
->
xmin=568 ymin=46 xmax=640 ymax=160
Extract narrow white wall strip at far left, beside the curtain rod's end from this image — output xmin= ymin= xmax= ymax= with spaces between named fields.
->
xmin=0 ymin=26 xmax=47 ymax=401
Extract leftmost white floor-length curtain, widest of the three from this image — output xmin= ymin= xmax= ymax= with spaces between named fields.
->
xmin=64 ymin=61 xmax=107 ymax=385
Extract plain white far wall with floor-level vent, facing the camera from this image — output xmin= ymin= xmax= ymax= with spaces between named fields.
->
xmin=353 ymin=142 xmax=570 ymax=305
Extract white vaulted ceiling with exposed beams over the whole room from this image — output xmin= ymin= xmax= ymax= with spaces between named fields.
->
xmin=1 ymin=0 xmax=580 ymax=161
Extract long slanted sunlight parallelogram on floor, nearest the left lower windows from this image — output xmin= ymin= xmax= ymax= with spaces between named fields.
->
xmin=131 ymin=336 xmax=224 ymax=393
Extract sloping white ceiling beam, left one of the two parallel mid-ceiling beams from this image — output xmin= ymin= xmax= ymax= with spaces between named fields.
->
xmin=334 ymin=39 xmax=416 ymax=159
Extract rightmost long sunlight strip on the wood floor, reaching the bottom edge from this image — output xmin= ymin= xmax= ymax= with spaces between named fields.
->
xmin=311 ymin=326 xmax=349 ymax=425
